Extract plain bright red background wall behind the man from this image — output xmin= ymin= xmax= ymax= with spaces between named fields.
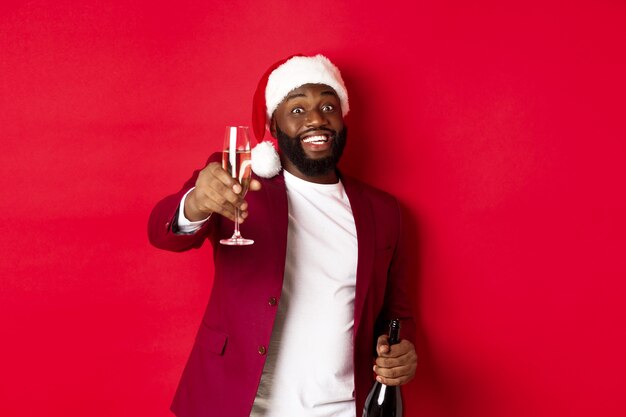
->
xmin=0 ymin=0 xmax=626 ymax=417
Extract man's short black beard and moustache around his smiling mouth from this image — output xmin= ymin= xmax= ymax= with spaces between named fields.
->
xmin=276 ymin=122 xmax=348 ymax=177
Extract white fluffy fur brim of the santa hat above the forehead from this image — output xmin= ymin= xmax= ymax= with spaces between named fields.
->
xmin=265 ymin=55 xmax=350 ymax=120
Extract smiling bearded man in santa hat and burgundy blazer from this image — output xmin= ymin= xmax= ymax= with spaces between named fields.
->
xmin=149 ymin=55 xmax=417 ymax=417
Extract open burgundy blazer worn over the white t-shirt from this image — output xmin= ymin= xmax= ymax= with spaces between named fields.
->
xmin=148 ymin=156 xmax=415 ymax=417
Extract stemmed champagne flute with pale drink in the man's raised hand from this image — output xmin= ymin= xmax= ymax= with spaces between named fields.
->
xmin=220 ymin=126 xmax=254 ymax=246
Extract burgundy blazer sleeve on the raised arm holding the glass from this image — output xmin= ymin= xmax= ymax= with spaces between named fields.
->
xmin=148 ymin=152 xmax=221 ymax=252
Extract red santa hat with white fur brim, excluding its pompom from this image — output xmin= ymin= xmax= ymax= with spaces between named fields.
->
xmin=252 ymin=55 xmax=350 ymax=142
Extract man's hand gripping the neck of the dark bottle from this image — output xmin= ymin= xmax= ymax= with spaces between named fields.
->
xmin=374 ymin=335 xmax=417 ymax=386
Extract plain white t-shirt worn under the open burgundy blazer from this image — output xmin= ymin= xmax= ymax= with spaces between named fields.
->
xmin=251 ymin=172 xmax=358 ymax=417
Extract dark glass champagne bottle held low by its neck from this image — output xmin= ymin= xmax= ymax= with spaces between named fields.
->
xmin=363 ymin=319 xmax=402 ymax=417
